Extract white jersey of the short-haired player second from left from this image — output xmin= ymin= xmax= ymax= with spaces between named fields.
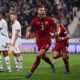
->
xmin=12 ymin=20 xmax=21 ymax=40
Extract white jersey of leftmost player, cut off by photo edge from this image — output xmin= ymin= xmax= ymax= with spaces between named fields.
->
xmin=0 ymin=19 xmax=8 ymax=37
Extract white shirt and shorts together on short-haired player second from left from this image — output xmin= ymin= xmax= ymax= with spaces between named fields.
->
xmin=12 ymin=20 xmax=21 ymax=54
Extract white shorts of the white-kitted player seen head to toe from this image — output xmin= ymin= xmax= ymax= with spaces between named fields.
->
xmin=12 ymin=38 xmax=21 ymax=54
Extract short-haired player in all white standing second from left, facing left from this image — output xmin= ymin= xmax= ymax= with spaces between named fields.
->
xmin=10 ymin=13 xmax=22 ymax=71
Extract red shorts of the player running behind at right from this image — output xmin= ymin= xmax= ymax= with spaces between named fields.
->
xmin=53 ymin=45 xmax=68 ymax=54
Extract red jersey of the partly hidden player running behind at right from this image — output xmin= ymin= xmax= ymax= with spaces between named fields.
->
xmin=53 ymin=24 xmax=68 ymax=45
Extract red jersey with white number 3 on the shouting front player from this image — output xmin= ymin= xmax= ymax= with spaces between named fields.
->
xmin=30 ymin=16 xmax=57 ymax=43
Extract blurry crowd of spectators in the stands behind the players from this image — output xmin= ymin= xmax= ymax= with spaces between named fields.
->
xmin=0 ymin=0 xmax=80 ymax=38
